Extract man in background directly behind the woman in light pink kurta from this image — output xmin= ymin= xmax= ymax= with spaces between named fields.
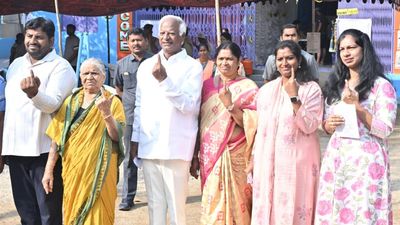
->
xmin=262 ymin=24 xmax=319 ymax=82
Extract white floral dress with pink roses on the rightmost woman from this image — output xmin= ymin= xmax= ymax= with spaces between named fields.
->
xmin=315 ymin=78 xmax=397 ymax=225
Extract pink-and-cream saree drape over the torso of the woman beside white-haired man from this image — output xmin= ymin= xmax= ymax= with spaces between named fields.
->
xmin=200 ymin=77 xmax=258 ymax=189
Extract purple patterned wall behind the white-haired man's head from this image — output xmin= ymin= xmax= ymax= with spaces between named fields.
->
xmin=134 ymin=3 xmax=256 ymax=61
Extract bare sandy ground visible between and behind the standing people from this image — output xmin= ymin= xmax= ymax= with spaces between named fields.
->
xmin=0 ymin=111 xmax=400 ymax=225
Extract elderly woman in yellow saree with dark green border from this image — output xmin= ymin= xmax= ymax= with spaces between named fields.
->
xmin=42 ymin=58 xmax=125 ymax=225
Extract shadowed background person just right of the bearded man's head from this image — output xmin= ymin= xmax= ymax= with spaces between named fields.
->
xmin=64 ymin=24 xmax=79 ymax=71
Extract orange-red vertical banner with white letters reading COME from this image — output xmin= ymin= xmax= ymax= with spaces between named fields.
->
xmin=117 ymin=12 xmax=132 ymax=60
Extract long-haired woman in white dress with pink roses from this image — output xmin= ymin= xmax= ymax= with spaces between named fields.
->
xmin=315 ymin=29 xmax=397 ymax=225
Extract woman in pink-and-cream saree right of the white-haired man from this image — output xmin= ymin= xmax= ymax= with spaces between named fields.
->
xmin=192 ymin=42 xmax=258 ymax=225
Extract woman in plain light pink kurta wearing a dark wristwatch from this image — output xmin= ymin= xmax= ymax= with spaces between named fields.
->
xmin=252 ymin=41 xmax=323 ymax=225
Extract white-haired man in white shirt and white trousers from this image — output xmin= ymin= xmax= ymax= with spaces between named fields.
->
xmin=131 ymin=15 xmax=202 ymax=225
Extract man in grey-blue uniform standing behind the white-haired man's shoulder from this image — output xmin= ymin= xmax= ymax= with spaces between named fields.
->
xmin=114 ymin=28 xmax=152 ymax=211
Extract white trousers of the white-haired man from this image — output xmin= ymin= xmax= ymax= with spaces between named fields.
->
xmin=143 ymin=159 xmax=190 ymax=225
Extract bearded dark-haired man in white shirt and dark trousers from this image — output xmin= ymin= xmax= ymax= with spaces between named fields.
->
xmin=2 ymin=17 xmax=76 ymax=225
